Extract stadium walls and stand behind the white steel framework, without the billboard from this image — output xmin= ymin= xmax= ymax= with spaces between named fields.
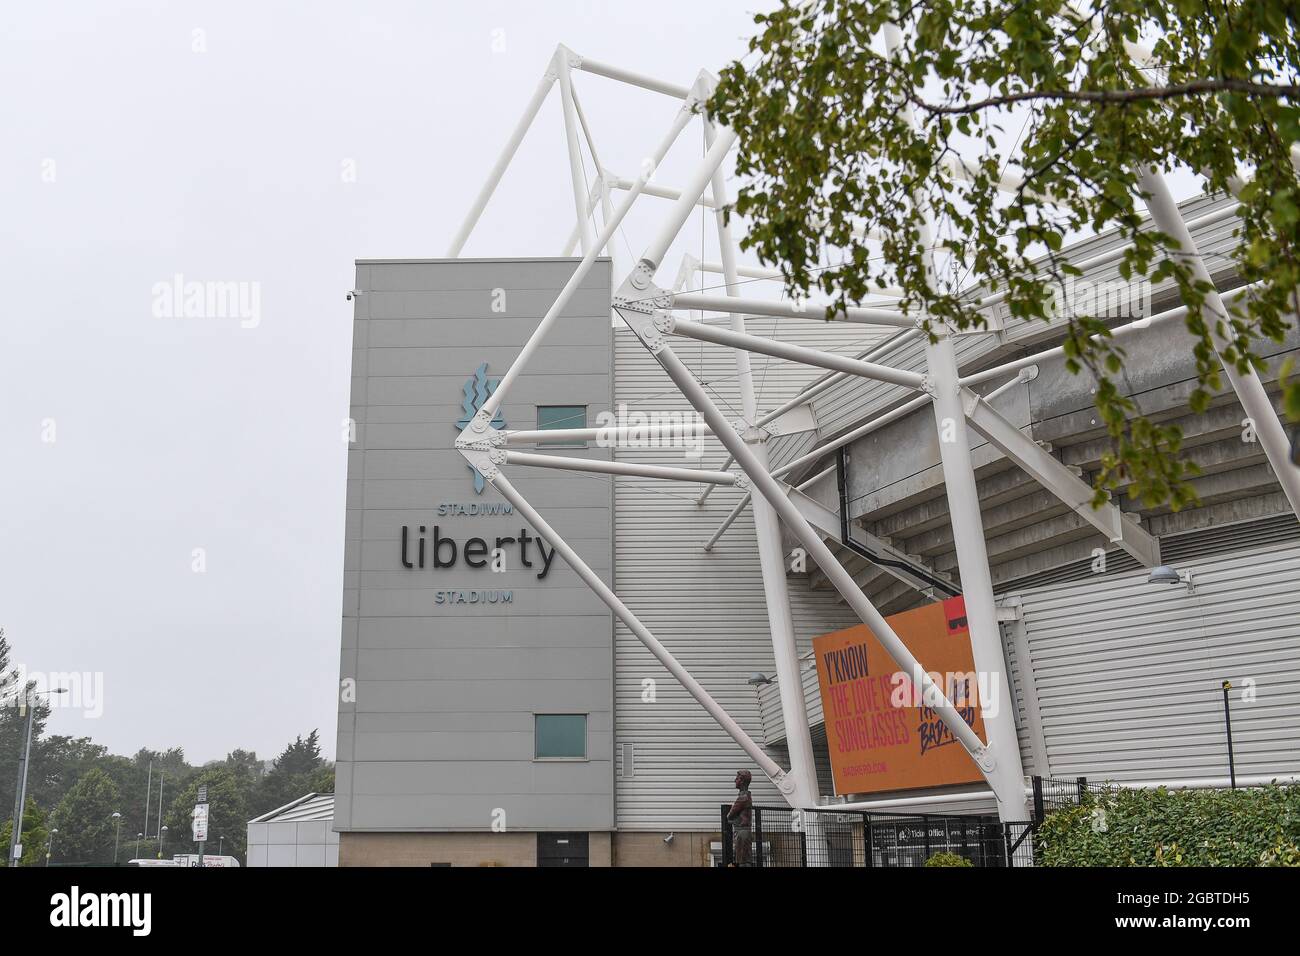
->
xmin=334 ymin=191 xmax=1300 ymax=866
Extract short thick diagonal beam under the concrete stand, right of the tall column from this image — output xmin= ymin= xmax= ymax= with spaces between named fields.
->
xmin=961 ymin=378 xmax=1160 ymax=567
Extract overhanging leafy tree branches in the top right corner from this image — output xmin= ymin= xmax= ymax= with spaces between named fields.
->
xmin=709 ymin=0 xmax=1300 ymax=510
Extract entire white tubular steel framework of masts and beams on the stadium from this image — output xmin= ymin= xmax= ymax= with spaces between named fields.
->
xmin=447 ymin=29 xmax=1300 ymax=827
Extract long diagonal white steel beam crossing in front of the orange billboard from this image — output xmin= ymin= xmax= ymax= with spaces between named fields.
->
xmin=624 ymin=306 xmax=993 ymax=785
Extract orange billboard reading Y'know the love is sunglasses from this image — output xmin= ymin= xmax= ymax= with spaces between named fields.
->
xmin=813 ymin=596 xmax=984 ymax=795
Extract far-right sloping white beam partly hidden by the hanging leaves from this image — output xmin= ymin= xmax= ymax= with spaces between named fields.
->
xmin=1138 ymin=168 xmax=1300 ymax=516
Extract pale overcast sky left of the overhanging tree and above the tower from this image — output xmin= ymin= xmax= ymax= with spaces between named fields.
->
xmin=0 ymin=0 xmax=767 ymax=762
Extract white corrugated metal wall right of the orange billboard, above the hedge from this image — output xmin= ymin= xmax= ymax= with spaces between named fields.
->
xmin=1018 ymin=541 xmax=1300 ymax=780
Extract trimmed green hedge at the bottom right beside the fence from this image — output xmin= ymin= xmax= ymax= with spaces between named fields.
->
xmin=1035 ymin=786 xmax=1300 ymax=866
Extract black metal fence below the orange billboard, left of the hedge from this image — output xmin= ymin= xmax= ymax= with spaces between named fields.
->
xmin=720 ymin=804 xmax=1034 ymax=868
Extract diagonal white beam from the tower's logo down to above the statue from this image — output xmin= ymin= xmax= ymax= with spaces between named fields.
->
xmin=483 ymin=468 xmax=790 ymax=795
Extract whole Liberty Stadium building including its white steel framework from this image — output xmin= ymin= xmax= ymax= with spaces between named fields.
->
xmin=333 ymin=47 xmax=1300 ymax=866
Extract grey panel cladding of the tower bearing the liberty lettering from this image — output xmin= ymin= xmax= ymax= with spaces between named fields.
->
xmin=334 ymin=259 xmax=614 ymax=831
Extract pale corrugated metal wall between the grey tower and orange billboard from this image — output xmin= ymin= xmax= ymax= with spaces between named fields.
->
xmin=615 ymin=319 xmax=880 ymax=830
